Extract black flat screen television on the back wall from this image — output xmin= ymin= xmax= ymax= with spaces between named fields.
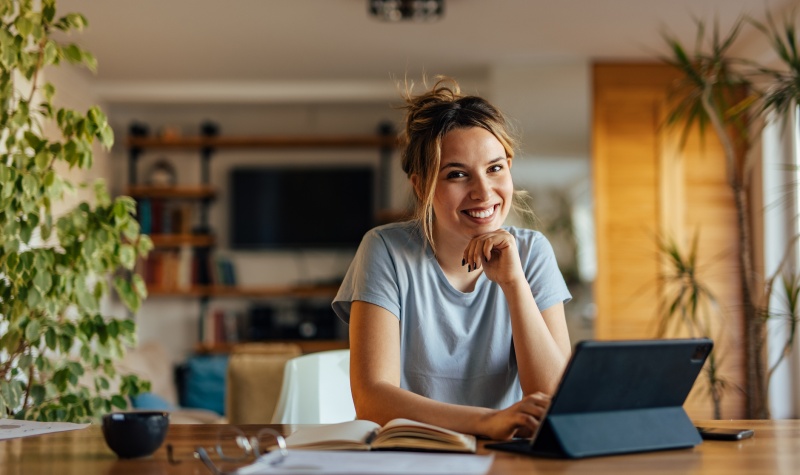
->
xmin=229 ymin=166 xmax=375 ymax=250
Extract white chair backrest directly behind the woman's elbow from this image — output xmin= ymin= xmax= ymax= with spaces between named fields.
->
xmin=272 ymin=350 xmax=356 ymax=424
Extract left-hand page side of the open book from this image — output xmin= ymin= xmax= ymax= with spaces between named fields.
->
xmin=286 ymin=420 xmax=380 ymax=450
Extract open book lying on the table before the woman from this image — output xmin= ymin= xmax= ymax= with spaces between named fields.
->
xmin=286 ymin=419 xmax=476 ymax=452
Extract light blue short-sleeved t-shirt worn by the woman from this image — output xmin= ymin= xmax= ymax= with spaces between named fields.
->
xmin=333 ymin=222 xmax=571 ymax=409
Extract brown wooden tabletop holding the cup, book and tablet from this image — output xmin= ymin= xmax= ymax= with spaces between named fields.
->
xmin=0 ymin=420 xmax=800 ymax=475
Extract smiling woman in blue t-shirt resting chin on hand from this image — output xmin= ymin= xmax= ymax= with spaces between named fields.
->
xmin=333 ymin=78 xmax=571 ymax=439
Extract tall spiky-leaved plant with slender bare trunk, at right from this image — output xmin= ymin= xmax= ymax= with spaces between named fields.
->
xmin=664 ymin=10 xmax=800 ymax=418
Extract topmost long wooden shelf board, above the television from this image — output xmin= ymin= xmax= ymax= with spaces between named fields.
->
xmin=128 ymin=135 xmax=398 ymax=150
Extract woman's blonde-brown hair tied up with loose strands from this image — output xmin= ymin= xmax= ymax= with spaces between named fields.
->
xmin=401 ymin=76 xmax=530 ymax=252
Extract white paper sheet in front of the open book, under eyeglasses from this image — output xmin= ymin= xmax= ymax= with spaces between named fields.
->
xmin=236 ymin=450 xmax=494 ymax=475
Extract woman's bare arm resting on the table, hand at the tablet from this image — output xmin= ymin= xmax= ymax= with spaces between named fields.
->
xmin=350 ymin=301 xmax=549 ymax=440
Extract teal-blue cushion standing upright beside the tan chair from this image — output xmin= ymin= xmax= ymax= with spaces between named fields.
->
xmin=183 ymin=355 xmax=228 ymax=414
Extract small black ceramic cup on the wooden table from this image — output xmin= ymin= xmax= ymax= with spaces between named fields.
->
xmin=103 ymin=411 xmax=169 ymax=458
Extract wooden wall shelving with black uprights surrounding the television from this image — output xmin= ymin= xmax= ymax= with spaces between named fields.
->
xmin=126 ymin=123 xmax=398 ymax=353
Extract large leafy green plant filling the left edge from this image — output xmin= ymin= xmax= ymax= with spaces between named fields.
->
xmin=0 ymin=0 xmax=152 ymax=421
